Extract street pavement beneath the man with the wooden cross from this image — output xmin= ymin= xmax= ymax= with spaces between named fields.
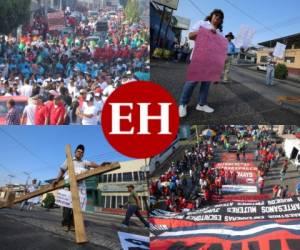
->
xmin=0 ymin=207 xmax=149 ymax=250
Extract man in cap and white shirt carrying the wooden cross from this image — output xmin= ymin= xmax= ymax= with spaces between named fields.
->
xmin=52 ymin=144 xmax=107 ymax=231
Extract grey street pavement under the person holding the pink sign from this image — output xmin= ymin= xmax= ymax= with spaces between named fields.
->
xmin=151 ymin=59 xmax=300 ymax=125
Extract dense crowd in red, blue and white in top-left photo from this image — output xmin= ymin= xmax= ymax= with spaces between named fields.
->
xmin=0 ymin=6 xmax=150 ymax=125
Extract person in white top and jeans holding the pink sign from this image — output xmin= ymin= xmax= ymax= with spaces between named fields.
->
xmin=179 ymin=9 xmax=224 ymax=117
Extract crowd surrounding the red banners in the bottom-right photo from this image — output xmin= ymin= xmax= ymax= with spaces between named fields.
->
xmin=149 ymin=126 xmax=289 ymax=212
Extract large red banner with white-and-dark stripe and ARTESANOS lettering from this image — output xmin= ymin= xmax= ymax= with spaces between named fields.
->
xmin=150 ymin=197 xmax=300 ymax=250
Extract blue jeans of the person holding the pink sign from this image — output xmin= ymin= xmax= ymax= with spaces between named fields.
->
xmin=180 ymin=81 xmax=210 ymax=106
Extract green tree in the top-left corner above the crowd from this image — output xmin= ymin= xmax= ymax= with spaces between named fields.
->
xmin=0 ymin=0 xmax=31 ymax=34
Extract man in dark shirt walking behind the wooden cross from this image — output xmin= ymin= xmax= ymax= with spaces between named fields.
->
xmin=121 ymin=184 xmax=149 ymax=228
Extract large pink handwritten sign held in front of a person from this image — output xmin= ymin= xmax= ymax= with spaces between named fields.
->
xmin=186 ymin=27 xmax=228 ymax=82
